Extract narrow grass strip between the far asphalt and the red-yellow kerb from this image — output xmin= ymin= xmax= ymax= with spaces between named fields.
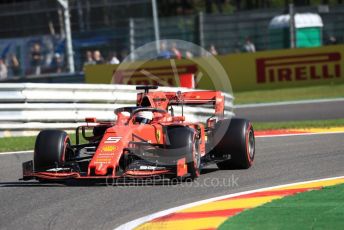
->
xmin=253 ymin=118 xmax=344 ymax=130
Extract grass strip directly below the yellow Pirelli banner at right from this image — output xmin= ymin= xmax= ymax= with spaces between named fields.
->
xmin=234 ymin=84 xmax=344 ymax=104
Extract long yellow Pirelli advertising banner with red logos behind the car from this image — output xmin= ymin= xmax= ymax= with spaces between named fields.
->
xmin=85 ymin=45 xmax=344 ymax=92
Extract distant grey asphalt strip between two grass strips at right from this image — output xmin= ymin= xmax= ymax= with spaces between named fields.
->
xmin=234 ymin=100 xmax=344 ymax=122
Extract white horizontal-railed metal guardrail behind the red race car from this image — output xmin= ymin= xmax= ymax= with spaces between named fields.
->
xmin=0 ymin=83 xmax=234 ymax=133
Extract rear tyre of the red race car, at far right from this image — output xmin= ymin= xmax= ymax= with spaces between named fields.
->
xmin=214 ymin=118 xmax=255 ymax=170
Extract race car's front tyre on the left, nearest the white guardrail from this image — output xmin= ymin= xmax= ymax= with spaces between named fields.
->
xmin=33 ymin=130 xmax=71 ymax=171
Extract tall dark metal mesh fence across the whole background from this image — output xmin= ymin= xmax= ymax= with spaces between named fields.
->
xmin=0 ymin=0 xmax=344 ymax=77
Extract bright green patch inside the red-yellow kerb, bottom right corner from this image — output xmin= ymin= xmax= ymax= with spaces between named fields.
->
xmin=219 ymin=184 xmax=344 ymax=230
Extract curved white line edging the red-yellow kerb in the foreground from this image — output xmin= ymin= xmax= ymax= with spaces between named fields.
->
xmin=115 ymin=176 xmax=344 ymax=230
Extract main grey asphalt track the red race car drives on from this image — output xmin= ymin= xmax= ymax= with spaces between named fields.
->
xmin=0 ymin=134 xmax=344 ymax=229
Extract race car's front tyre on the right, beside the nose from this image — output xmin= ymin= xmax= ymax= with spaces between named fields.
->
xmin=167 ymin=126 xmax=201 ymax=180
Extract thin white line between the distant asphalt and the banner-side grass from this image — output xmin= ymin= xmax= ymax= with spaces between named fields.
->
xmin=234 ymin=98 xmax=344 ymax=109
